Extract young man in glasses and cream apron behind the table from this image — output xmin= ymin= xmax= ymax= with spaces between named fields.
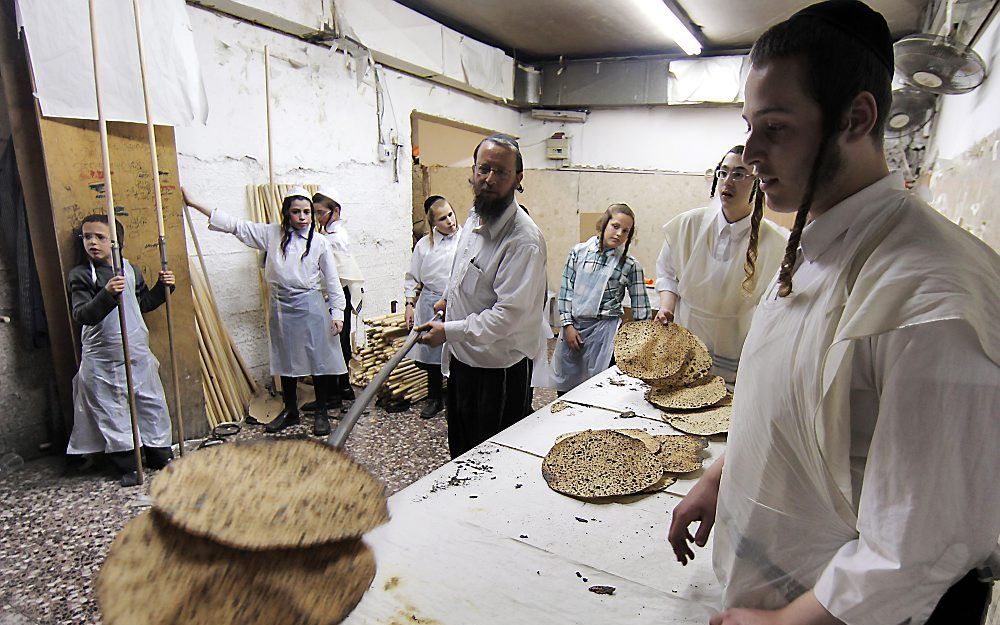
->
xmin=655 ymin=145 xmax=785 ymax=384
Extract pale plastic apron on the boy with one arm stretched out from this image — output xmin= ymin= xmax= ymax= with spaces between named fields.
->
xmin=269 ymin=286 xmax=347 ymax=378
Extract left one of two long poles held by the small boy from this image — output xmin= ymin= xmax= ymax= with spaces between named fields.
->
xmin=89 ymin=0 xmax=143 ymax=485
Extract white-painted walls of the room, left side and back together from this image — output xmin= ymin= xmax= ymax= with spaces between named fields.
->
xmin=176 ymin=7 xmax=743 ymax=386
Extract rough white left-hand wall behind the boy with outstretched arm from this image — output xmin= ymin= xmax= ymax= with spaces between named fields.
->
xmin=176 ymin=7 xmax=521 ymax=379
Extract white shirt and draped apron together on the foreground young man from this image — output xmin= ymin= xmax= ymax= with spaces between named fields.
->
xmin=713 ymin=176 xmax=1000 ymax=625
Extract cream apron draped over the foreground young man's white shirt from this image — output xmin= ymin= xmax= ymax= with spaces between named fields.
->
xmin=713 ymin=191 xmax=1000 ymax=609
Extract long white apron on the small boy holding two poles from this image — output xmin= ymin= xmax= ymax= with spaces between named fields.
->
xmin=66 ymin=259 xmax=171 ymax=454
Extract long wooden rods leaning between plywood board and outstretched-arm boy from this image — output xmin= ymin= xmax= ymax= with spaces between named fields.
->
xmin=191 ymin=263 xmax=257 ymax=428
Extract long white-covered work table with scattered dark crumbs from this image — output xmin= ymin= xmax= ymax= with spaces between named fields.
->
xmin=345 ymin=367 xmax=725 ymax=625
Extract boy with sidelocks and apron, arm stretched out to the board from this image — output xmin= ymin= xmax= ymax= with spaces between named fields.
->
xmin=182 ymin=187 xmax=347 ymax=436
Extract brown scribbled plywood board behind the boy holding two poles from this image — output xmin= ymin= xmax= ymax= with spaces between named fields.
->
xmin=38 ymin=118 xmax=207 ymax=437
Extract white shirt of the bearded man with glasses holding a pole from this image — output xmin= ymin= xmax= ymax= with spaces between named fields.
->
xmin=442 ymin=200 xmax=546 ymax=369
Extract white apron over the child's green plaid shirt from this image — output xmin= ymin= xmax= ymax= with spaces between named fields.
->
xmin=552 ymin=236 xmax=622 ymax=391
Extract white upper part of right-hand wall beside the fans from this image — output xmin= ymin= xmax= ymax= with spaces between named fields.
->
xmin=931 ymin=16 xmax=1000 ymax=159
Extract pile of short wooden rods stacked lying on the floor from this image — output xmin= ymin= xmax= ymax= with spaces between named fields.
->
xmin=351 ymin=313 xmax=427 ymax=403
